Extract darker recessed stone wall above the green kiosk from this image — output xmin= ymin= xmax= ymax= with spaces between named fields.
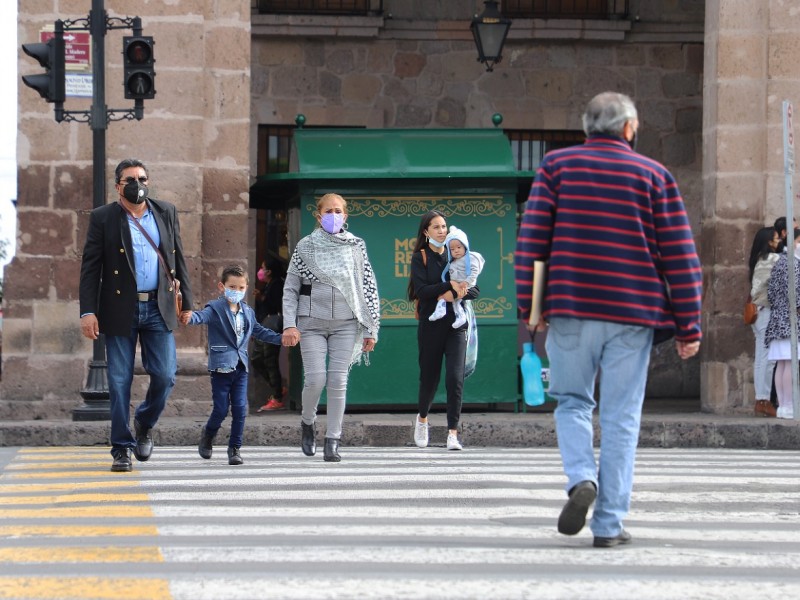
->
xmin=251 ymin=0 xmax=703 ymax=398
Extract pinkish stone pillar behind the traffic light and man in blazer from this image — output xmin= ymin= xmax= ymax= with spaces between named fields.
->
xmin=0 ymin=0 xmax=250 ymax=418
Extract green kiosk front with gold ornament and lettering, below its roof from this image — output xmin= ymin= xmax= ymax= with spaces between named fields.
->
xmin=301 ymin=193 xmax=518 ymax=406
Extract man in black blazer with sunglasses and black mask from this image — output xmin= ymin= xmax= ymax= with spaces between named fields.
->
xmin=80 ymin=159 xmax=192 ymax=471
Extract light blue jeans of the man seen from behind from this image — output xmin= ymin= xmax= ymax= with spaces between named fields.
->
xmin=546 ymin=318 xmax=653 ymax=537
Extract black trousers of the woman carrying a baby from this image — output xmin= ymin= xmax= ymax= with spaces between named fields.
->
xmin=417 ymin=314 xmax=467 ymax=429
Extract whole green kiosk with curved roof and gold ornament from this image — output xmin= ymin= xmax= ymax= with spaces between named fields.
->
xmin=250 ymin=128 xmax=532 ymax=408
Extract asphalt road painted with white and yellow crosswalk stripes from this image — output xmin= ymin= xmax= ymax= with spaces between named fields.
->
xmin=0 ymin=446 xmax=800 ymax=600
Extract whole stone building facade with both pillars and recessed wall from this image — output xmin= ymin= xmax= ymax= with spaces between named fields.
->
xmin=0 ymin=0 xmax=800 ymax=418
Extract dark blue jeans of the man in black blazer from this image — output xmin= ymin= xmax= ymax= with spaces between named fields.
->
xmin=106 ymin=300 xmax=178 ymax=448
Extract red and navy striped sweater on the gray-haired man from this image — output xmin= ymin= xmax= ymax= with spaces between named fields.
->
xmin=514 ymin=135 xmax=702 ymax=341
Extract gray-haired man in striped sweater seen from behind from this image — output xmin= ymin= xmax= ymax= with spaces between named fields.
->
xmin=514 ymin=92 xmax=702 ymax=548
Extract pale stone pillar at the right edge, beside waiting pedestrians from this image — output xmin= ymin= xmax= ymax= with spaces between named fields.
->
xmin=702 ymin=0 xmax=800 ymax=413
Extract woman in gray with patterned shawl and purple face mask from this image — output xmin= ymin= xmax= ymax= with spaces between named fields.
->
xmin=283 ymin=194 xmax=380 ymax=462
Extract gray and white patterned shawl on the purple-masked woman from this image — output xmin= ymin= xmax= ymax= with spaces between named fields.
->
xmin=288 ymin=228 xmax=380 ymax=366
